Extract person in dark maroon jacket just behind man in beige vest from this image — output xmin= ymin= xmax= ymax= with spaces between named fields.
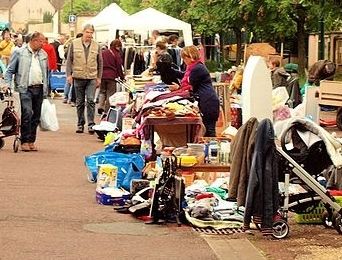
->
xmin=97 ymin=39 xmax=124 ymax=114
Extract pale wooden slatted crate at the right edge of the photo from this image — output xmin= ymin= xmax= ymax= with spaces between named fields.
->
xmin=319 ymin=80 xmax=342 ymax=107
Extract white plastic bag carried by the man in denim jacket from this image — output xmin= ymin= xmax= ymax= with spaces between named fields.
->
xmin=40 ymin=98 xmax=59 ymax=131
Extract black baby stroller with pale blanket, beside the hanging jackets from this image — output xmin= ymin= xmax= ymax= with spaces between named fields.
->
xmin=273 ymin=118 xmax=342 ymax=238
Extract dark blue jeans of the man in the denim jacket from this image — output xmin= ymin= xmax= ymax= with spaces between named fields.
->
xmin=20 ymin=86 xmax=43 ymax=144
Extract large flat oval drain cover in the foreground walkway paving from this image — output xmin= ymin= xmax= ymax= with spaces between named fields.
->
xmin=83 ymin=222 xmax=169 ymax=236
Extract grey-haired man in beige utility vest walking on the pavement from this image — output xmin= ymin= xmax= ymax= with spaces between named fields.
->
xmin=66 ymin=24 xmax=103 ymax=134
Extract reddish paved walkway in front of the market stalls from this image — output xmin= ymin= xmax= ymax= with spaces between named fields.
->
xmin=0 ymin=97 xmax=262 ymax=260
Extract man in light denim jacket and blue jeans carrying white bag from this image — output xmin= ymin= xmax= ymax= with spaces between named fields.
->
xmin=5 ymin=32 xmax=48 ymax=152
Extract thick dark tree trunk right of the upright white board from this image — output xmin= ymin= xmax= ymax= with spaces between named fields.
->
xmin=296 ymin=7 xmax=307 ymax=76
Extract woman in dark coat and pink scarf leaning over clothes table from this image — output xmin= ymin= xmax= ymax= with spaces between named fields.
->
xmin=170 ymin=45 xmax=220 ymax=137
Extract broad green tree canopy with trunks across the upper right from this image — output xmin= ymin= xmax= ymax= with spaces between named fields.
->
xmin=183 ymin=0 xmax=342 ymax=71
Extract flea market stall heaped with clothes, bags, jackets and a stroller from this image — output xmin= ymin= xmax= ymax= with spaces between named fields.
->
xmin=81 ymin=53 xmax=342 ymax=239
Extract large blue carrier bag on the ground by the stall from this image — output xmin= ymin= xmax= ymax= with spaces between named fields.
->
xmin=85 ymin=150 xmax=145 ymax=190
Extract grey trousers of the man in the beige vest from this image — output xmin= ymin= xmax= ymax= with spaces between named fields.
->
xmin=74 ymin=79 xmax=96 ymax=126
